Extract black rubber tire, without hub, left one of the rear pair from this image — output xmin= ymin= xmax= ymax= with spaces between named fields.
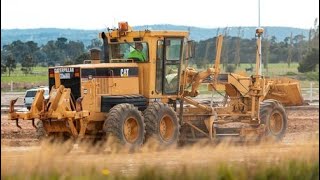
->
xmin=103 ymin=103 xmax=146 ymax=148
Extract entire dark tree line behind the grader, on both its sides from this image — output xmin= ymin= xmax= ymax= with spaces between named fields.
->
xmin=1 ymin=25 xmax=319 ymax=76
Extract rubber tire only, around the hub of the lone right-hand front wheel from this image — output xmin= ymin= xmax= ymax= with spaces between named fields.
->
xmin=259 ymin=99 xmax=288 ymax=141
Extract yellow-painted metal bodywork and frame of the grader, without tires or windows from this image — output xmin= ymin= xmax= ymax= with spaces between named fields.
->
xmin=9 ymin=23 xmax=303 ymax=143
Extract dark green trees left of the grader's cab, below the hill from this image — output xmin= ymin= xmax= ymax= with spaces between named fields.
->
xmin=1 ymin=37 xmax=101 ymax=76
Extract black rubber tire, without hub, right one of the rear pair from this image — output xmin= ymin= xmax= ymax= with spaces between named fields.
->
xmin=143 ymin=102 xmax=180 ymax=146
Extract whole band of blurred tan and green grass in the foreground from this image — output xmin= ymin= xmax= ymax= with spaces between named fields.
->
xmin=1 ymin=137 xmax=319 ymax=180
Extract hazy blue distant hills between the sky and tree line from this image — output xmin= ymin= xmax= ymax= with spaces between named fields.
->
xmin=1 ymin=24 xmax=309 ymax=47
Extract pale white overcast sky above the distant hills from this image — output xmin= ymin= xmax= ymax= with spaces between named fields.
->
xmin=1 ymin=0 xmax=319 ymax=30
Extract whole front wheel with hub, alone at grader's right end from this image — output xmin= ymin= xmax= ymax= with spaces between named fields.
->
xmin=260 ymin=99 xmax=288 ymax=141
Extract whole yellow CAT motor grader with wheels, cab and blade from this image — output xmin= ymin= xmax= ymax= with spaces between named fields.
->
xmin=8 ymin=22 xmax=303 ymax=147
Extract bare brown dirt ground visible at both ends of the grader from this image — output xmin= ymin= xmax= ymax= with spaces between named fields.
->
xmin=1 ymin=110 xmax=319 ymax=146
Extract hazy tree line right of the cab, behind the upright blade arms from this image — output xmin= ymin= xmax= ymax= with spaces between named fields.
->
xmin=192 ymin=25 xmax=319 ymax=72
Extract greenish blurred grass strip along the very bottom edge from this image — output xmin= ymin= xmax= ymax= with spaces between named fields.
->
xmin=1 ymin=160 xmax=319 ymax=180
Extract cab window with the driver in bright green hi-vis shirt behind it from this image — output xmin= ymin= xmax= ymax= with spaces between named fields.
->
xmin=109 ymin=42 xmax=149 ymax=62
